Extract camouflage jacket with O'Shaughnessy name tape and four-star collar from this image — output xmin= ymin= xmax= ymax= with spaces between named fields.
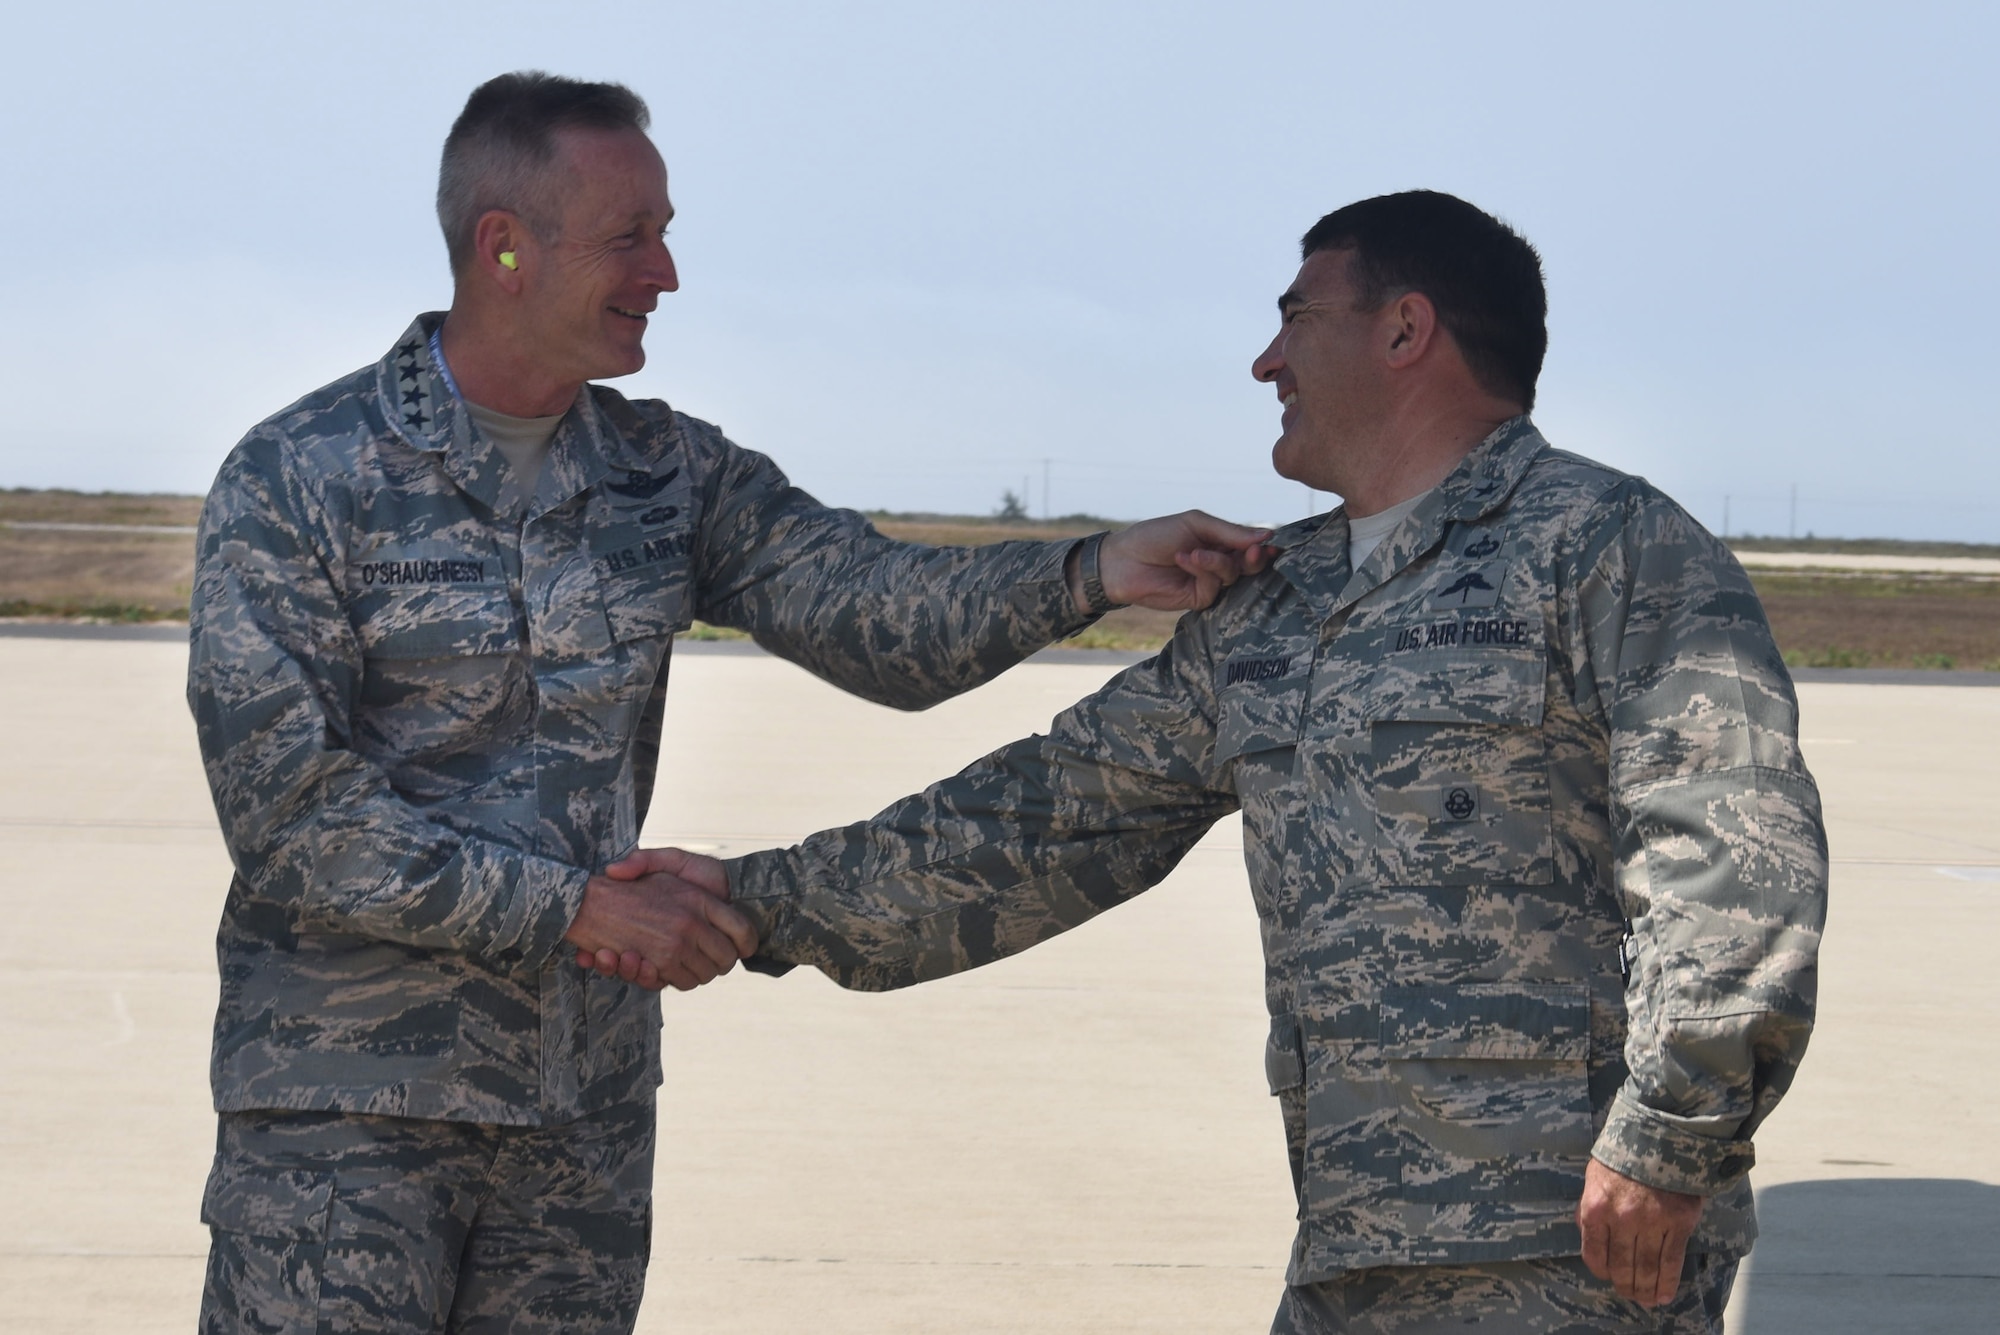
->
xmin=188 ymin=316 xmax=1086 ymax=1125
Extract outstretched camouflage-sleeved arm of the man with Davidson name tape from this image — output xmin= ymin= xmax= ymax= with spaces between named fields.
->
xmin=730 ymin=639 xmax=1236 ymax=987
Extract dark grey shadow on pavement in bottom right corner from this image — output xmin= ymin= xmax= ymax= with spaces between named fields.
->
xmin=1732 ymin=1177 xmax=2000 ymax=1335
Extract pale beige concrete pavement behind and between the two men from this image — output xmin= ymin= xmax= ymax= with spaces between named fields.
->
xmin=0 ymin=636 xmax=2000 ymax=1335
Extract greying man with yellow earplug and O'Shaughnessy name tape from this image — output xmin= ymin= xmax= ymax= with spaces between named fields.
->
xmin=188 ymin=74 xmax=1262 ymax=1331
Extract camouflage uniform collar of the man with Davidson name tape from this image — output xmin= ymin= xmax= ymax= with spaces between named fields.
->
xmin=1272 ymin=414 xmax=1548 ymax=618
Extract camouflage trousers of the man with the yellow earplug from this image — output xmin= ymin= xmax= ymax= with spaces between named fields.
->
xmin=200 ymin=1103 xmax=654 ymax=1335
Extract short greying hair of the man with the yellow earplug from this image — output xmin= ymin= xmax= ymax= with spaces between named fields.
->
xmin=438 ymin=70 xmax=652 ymax=274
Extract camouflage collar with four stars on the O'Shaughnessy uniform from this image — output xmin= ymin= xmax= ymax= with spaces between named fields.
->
xmin=376 ymin=310 xmax=616 ymax=522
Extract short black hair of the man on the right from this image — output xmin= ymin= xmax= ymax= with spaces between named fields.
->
xmin=1298 ymin=190 xmax=1548 ymax=410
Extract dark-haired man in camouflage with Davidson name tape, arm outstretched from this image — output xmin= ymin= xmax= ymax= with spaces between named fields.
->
xmin=624 ymin=192 xmax=1826 ymax=1335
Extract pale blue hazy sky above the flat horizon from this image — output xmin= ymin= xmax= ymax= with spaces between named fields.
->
xmin=0 ymin=0 xmax=2000 ymax=542
